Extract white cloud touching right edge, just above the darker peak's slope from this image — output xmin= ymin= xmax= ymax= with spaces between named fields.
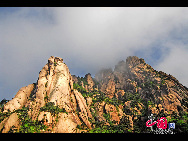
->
xmin=156 ymin=44 xmax=188 ymax=86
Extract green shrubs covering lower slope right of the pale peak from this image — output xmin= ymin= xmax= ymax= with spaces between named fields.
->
xmin=74 ymin=79 xmax=188 ymax=133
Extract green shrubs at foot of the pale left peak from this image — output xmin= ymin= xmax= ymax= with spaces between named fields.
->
xmin=0 ymin=102 xmax=68 ymax=133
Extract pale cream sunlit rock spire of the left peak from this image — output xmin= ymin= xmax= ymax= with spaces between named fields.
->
xmin=1 ymin=56 xmax=92 ymax=132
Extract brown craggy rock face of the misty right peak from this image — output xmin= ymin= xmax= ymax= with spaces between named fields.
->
xmin=95 ymin=56 xmax=188 ymax=113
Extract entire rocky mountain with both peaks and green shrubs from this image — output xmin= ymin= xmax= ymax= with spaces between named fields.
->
xmin=0 ymin=56 xmax=188 ymax=133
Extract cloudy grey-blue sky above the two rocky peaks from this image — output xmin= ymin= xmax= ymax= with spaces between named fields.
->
xmin=0 ymin=7 xmax=188 ymax=100
